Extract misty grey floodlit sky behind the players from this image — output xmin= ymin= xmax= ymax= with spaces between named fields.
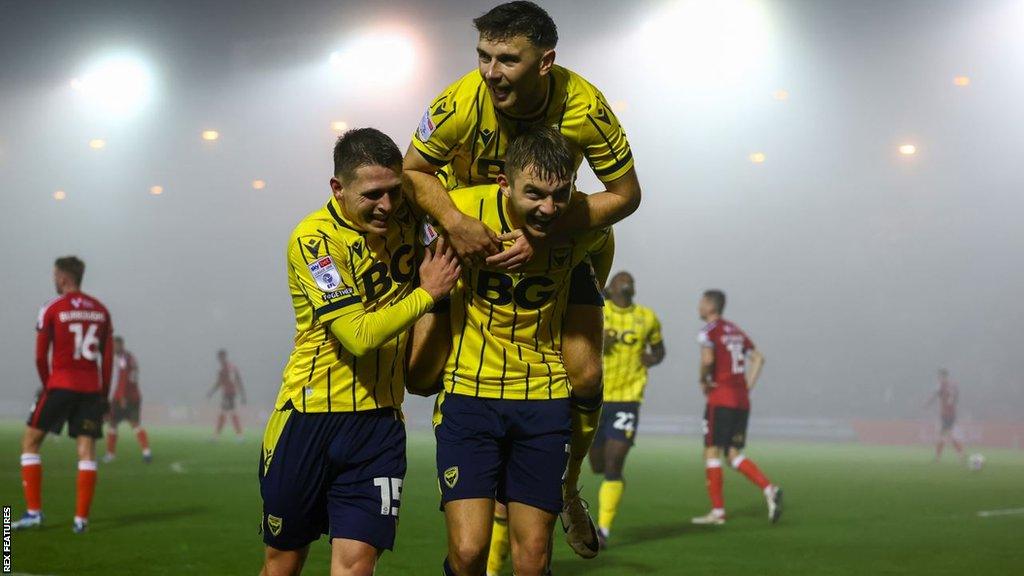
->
xmin=0 ymin=0 xmax=1024 ymax=419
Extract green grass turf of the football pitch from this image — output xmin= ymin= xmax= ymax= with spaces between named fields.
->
xmin=0 ymin=424 xmax=1024 ymax=576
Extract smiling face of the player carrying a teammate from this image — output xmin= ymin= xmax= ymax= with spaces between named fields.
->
xmin=498 ymin=166 xmax=572 ymax=239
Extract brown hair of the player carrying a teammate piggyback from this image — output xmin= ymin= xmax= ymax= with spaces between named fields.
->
xmin=505 ymin=124 xmax=575 ymax=180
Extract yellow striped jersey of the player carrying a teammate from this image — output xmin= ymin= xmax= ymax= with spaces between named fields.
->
xmin=442 ymin=184 xmax=613 ymax=400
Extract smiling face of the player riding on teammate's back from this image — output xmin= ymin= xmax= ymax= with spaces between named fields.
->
xmin=476 ymin=36 xmax=555 ymax=115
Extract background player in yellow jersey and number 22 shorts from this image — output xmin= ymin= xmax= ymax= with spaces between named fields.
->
xmin=590 ymin=272 xmax=665 ymax=547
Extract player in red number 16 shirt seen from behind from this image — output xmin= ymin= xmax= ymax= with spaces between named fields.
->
xmin=12 ymin=256 xmax=114 ymax=534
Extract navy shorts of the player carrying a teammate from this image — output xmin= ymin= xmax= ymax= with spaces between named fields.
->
xmin=434 ymin=394 xmax=571 ymax=513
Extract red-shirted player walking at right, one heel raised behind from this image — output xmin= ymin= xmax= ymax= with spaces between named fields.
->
xmin=692 ymin=290 xmax=782 ymax=524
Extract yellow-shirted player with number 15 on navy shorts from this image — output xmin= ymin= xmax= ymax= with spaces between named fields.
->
xmin=260 ymin=128 xmax=460 ymax=576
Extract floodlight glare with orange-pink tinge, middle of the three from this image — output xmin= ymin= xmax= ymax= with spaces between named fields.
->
xmin=329 ymin=30 xmax=417 ymax=88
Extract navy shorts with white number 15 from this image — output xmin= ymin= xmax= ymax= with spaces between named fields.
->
xmin=259 ymin=408 xmax=406 ymax=550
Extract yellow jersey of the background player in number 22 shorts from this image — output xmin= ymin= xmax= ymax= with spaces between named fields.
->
xmin=604 ymin=300 xmax=662 ymax=402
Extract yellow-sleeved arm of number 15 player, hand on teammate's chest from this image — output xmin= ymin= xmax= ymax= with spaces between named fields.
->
xmin=331 ymin=238 xmax=462 ymax=357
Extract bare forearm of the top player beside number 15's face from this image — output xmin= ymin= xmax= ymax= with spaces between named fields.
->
xmin=402 ymin=145 xmax=501 ymax=261
